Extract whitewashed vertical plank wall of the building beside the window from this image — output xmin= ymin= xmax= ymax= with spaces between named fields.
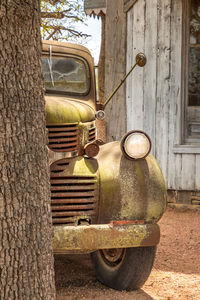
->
xmin=126 ymin=0 xmax=200 ymax=190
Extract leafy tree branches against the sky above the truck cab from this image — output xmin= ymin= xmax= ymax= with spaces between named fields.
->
xmin=41 ymin=0 xmax=88 ymax=41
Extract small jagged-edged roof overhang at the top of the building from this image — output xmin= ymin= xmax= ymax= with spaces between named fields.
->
xmin=84 ymin=0 xmax=107 ymax=16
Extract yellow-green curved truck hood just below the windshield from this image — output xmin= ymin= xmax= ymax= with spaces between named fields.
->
xmin=45 ymin=96 xmax=95 ymax=124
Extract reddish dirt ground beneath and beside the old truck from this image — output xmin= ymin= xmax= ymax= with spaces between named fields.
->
xmin=55 ymin=209 xmax=200 ymax=300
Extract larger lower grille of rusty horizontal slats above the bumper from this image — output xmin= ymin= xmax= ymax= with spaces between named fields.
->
xmin=50 ymin=159 xmax=97 ymax=225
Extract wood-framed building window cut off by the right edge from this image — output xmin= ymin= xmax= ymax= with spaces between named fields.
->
xmin=184 ymin=0 xmax=200 ymax=144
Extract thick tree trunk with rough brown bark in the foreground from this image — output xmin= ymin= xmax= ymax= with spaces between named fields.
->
xmin=0 ymin=0 xmax=55 ymax=300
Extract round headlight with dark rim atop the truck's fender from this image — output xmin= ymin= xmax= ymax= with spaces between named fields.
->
xmin=121 ymin=130 xmax=151 ymax=159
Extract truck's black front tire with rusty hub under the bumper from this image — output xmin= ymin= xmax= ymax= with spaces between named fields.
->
xmin=91 ymin=246 xmax=156 ymax=291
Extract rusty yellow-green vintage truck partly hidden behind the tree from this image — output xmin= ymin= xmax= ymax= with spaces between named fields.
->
xmin=42 ymin=41 xmax=166 ymax=290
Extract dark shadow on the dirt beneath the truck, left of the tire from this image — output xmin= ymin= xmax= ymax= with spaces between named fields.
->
xmin=55 ymin=255 xmax=153 ymax=300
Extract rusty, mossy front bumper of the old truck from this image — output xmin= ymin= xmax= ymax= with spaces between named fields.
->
xmin=53 ymin=221 xmax=160 ymax=253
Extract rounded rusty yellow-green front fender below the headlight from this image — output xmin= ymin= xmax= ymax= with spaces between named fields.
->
xmin=97 ymin=142 xmax=167 ymax=224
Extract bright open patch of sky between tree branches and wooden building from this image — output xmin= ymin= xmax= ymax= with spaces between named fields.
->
xmin=77 ymin=16 xmax=101 ymax=64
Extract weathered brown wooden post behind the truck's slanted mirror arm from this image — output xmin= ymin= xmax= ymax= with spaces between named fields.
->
xmin=105 ymin=0 xmax=127 ymax=141
